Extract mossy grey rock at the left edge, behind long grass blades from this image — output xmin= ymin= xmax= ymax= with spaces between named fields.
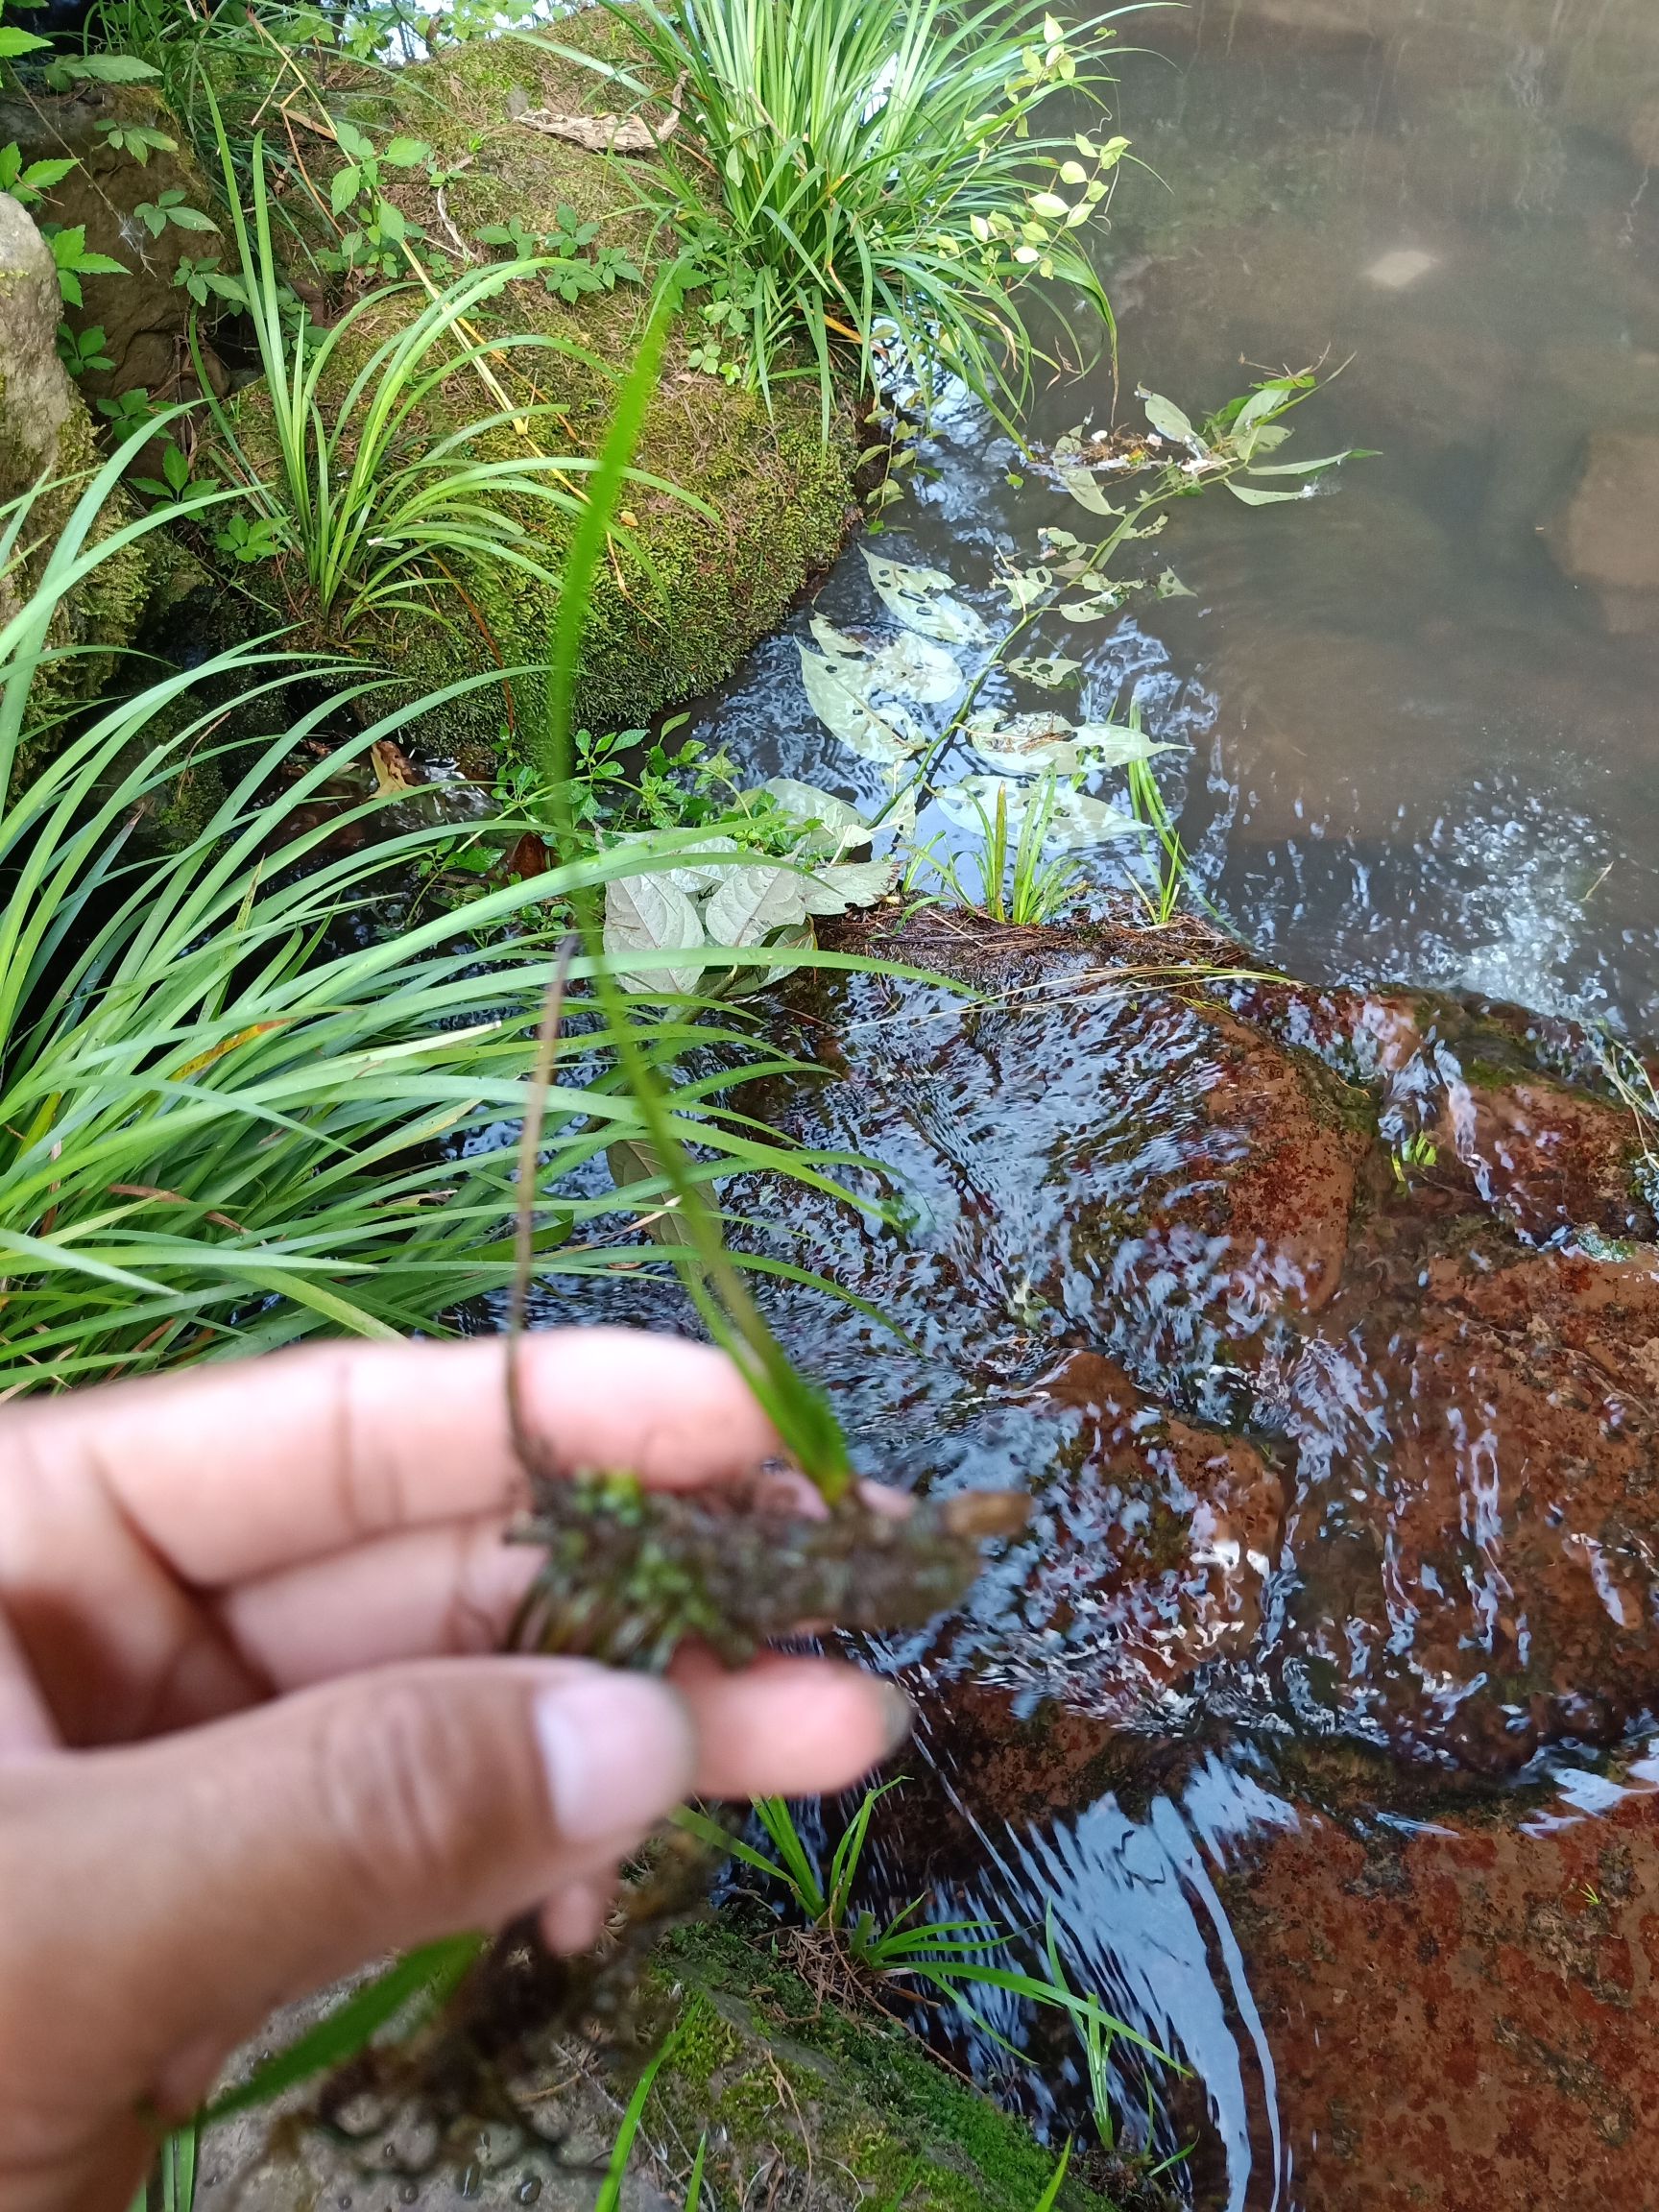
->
xmin=0 ymin=192 xmax=153 ymax=716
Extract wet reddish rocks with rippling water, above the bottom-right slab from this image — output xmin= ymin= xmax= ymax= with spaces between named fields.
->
xmin=739 ymin=914 xmax=1659 ymax=1776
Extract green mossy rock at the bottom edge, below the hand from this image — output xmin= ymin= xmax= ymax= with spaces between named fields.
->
xmin=197 ymin=1920 xmax=1123 ymax=2212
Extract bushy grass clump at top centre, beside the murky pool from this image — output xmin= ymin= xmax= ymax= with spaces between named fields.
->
xmin=579 ymin=0 xmax=1126 ymax=429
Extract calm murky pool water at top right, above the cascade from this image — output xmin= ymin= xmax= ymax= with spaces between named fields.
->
xmin=681 ymin=0 xmax=1659 ymax=1031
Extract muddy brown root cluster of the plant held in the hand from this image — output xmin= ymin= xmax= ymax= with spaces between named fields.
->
xmin=289 ymin=1473 xmax=1026 ymax=2178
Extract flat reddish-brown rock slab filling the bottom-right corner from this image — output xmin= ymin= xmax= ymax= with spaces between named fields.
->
xmin=1219 ymin=1790 xmax=1659 ymax=2212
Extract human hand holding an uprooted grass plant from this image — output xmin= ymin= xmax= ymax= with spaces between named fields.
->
xmin=0 ymin=1330 xmax=902 ymax=2212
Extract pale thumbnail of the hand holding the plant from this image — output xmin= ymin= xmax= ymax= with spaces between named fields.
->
xmin=536 ymin=1668 xmax=697 ymax=1842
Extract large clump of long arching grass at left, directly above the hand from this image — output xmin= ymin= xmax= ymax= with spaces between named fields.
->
xmin=0 ymin=431 xmax=871 ymax=1391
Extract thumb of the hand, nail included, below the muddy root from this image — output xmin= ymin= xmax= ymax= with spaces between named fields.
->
xmin=0 ymin=1659 xmax=697 ymax=2163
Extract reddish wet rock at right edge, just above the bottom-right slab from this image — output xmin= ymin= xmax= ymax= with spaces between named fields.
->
xmin=1283 ymin=1232 xmax=1659 ymax=1772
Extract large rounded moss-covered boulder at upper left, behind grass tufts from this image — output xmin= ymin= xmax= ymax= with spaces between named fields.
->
xmin=222 ymin=9 xmax=854 ymax=757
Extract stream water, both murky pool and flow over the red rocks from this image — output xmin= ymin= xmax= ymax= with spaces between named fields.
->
xmin=641 ymin=0 xmax=1659 ymax=2212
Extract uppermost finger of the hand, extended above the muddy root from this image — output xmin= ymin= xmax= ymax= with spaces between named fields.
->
xmin=0 ymin=1330 xmax=777 ymax=1588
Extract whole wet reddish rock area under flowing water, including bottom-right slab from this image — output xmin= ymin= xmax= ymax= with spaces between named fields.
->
xmin=741 ymin=914 xmax=1659 ymax=2212
